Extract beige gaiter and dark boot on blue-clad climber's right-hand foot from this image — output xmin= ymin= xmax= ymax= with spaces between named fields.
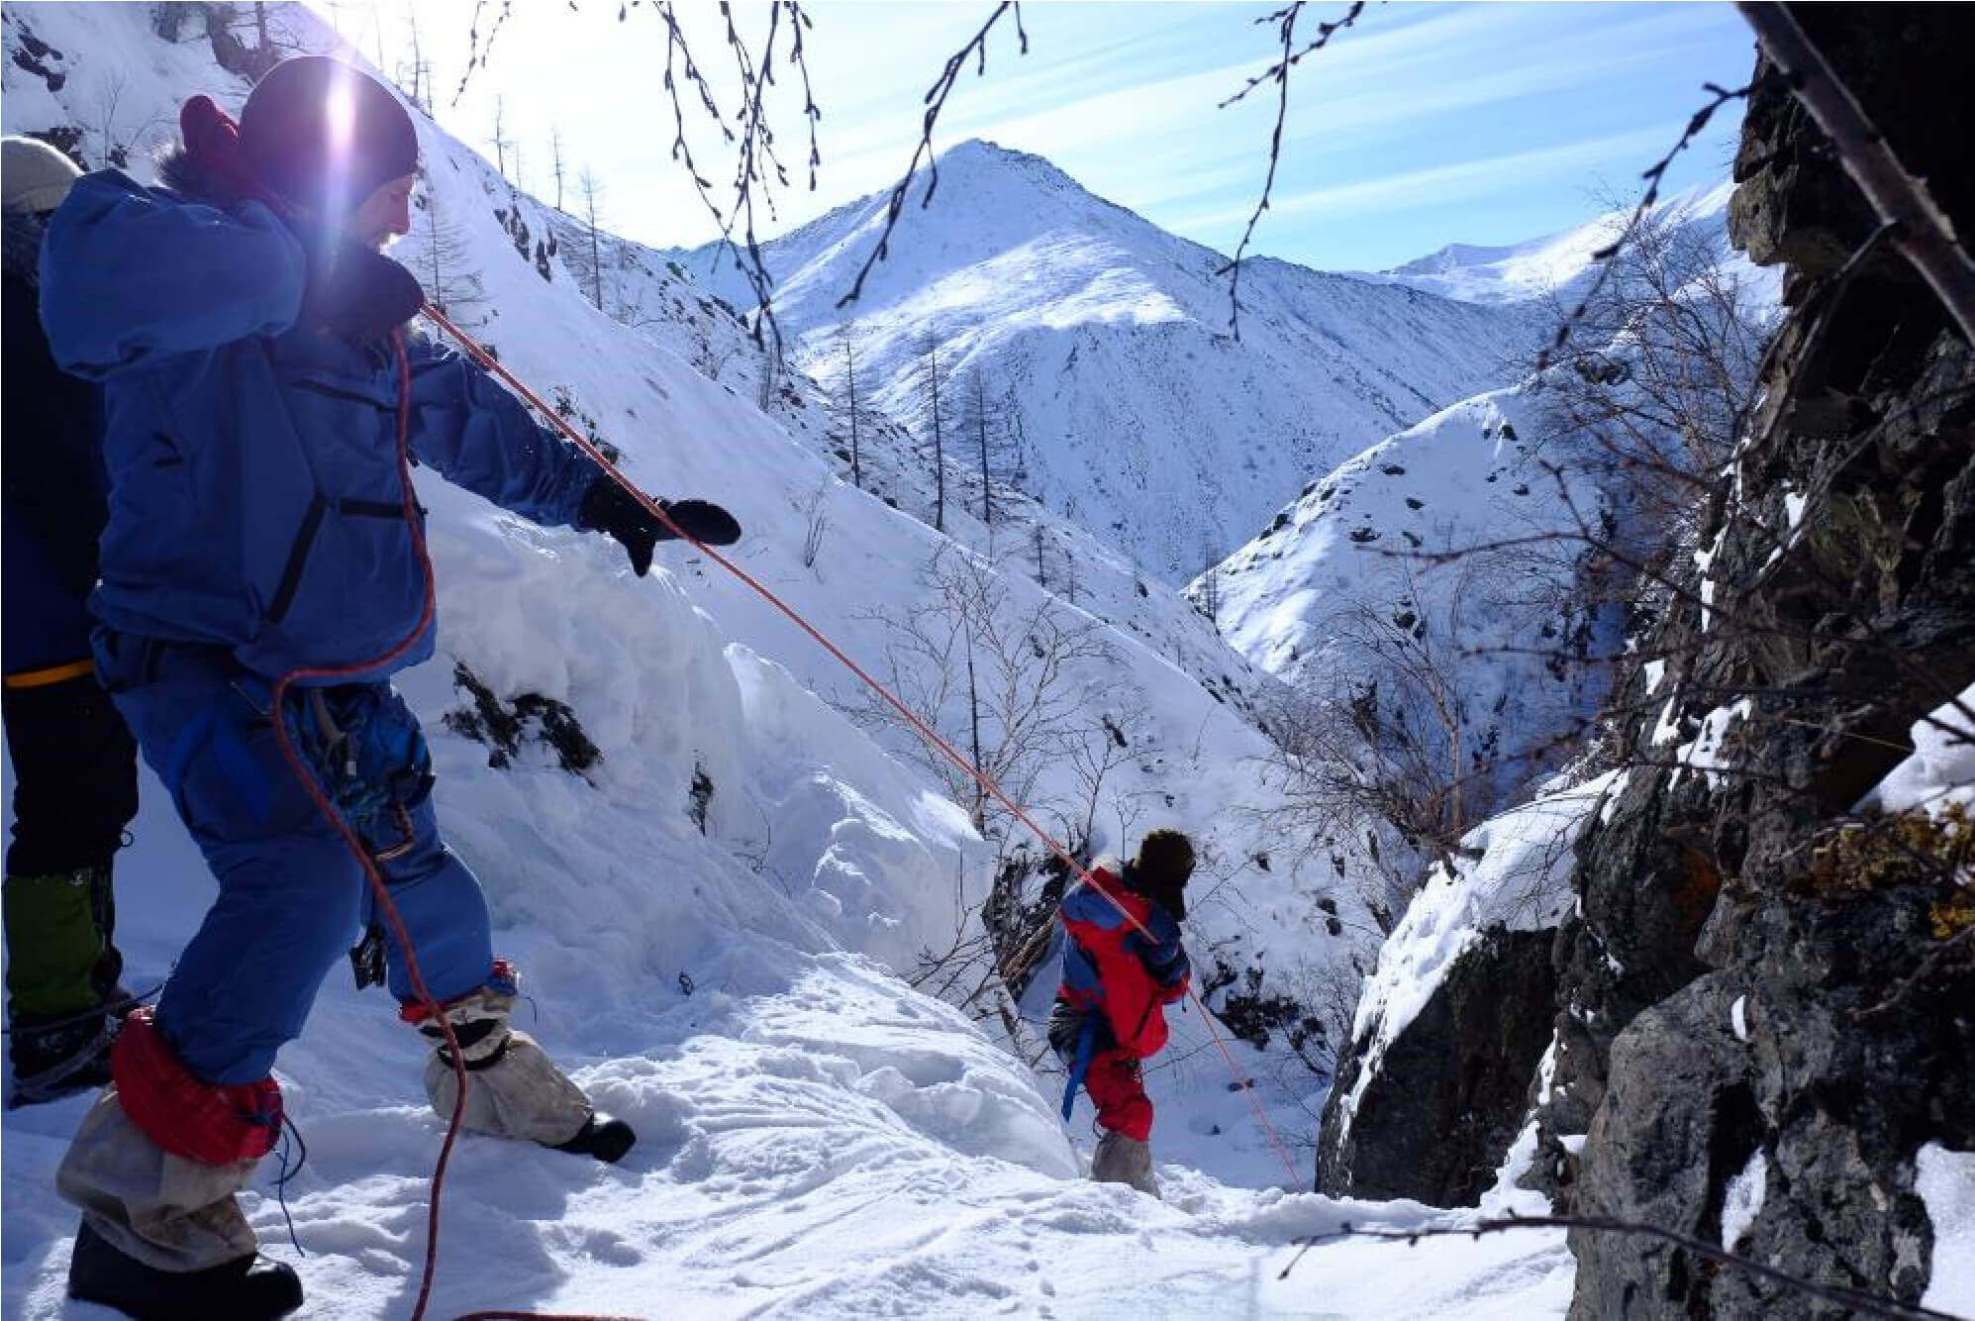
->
xmin=405 ymin=964 xmax=636 ymax=1161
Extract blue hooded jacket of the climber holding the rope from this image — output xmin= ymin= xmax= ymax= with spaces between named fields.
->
xmin=41 ymin=170 xmax=596 ymax=681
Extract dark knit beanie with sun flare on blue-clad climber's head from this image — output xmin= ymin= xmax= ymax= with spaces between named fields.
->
xmin=239 ymin=55 xmax=419 ymax=217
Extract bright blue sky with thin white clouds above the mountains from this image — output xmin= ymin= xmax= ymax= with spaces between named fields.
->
xmin=318 ymin=0 xmax=1754 ymax=271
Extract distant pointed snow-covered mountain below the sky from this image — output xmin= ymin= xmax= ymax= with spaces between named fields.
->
xmin=677 ymin=140 xmax=1529 ymax=583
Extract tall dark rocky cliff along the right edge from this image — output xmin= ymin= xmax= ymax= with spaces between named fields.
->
xmin=1539 ymin=6 xmax=1975 ymax=1321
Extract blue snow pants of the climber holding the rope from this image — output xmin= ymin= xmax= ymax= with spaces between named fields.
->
xmin=97 ymin=630 xmax=494 ymax=1084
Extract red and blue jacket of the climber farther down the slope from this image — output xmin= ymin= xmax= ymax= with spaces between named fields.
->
xmin=1051 ymin=863 xmax=1193 ymax=1114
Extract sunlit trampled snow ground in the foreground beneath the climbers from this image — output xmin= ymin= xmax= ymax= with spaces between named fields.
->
xmin=4 ymin=825 xmax=1572 ymax=1321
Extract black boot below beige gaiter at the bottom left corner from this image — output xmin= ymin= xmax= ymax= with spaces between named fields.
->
xmin=69 ymin=1220 xmax=302 ymax=1321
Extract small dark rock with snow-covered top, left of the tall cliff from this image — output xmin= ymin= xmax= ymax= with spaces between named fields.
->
xmin=1317 ymin=928 xmax=1556 ymax=1206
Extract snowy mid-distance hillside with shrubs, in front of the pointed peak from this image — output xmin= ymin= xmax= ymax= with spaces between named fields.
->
xmin=1187 ymin=379 xmax=1618 ymax=819
